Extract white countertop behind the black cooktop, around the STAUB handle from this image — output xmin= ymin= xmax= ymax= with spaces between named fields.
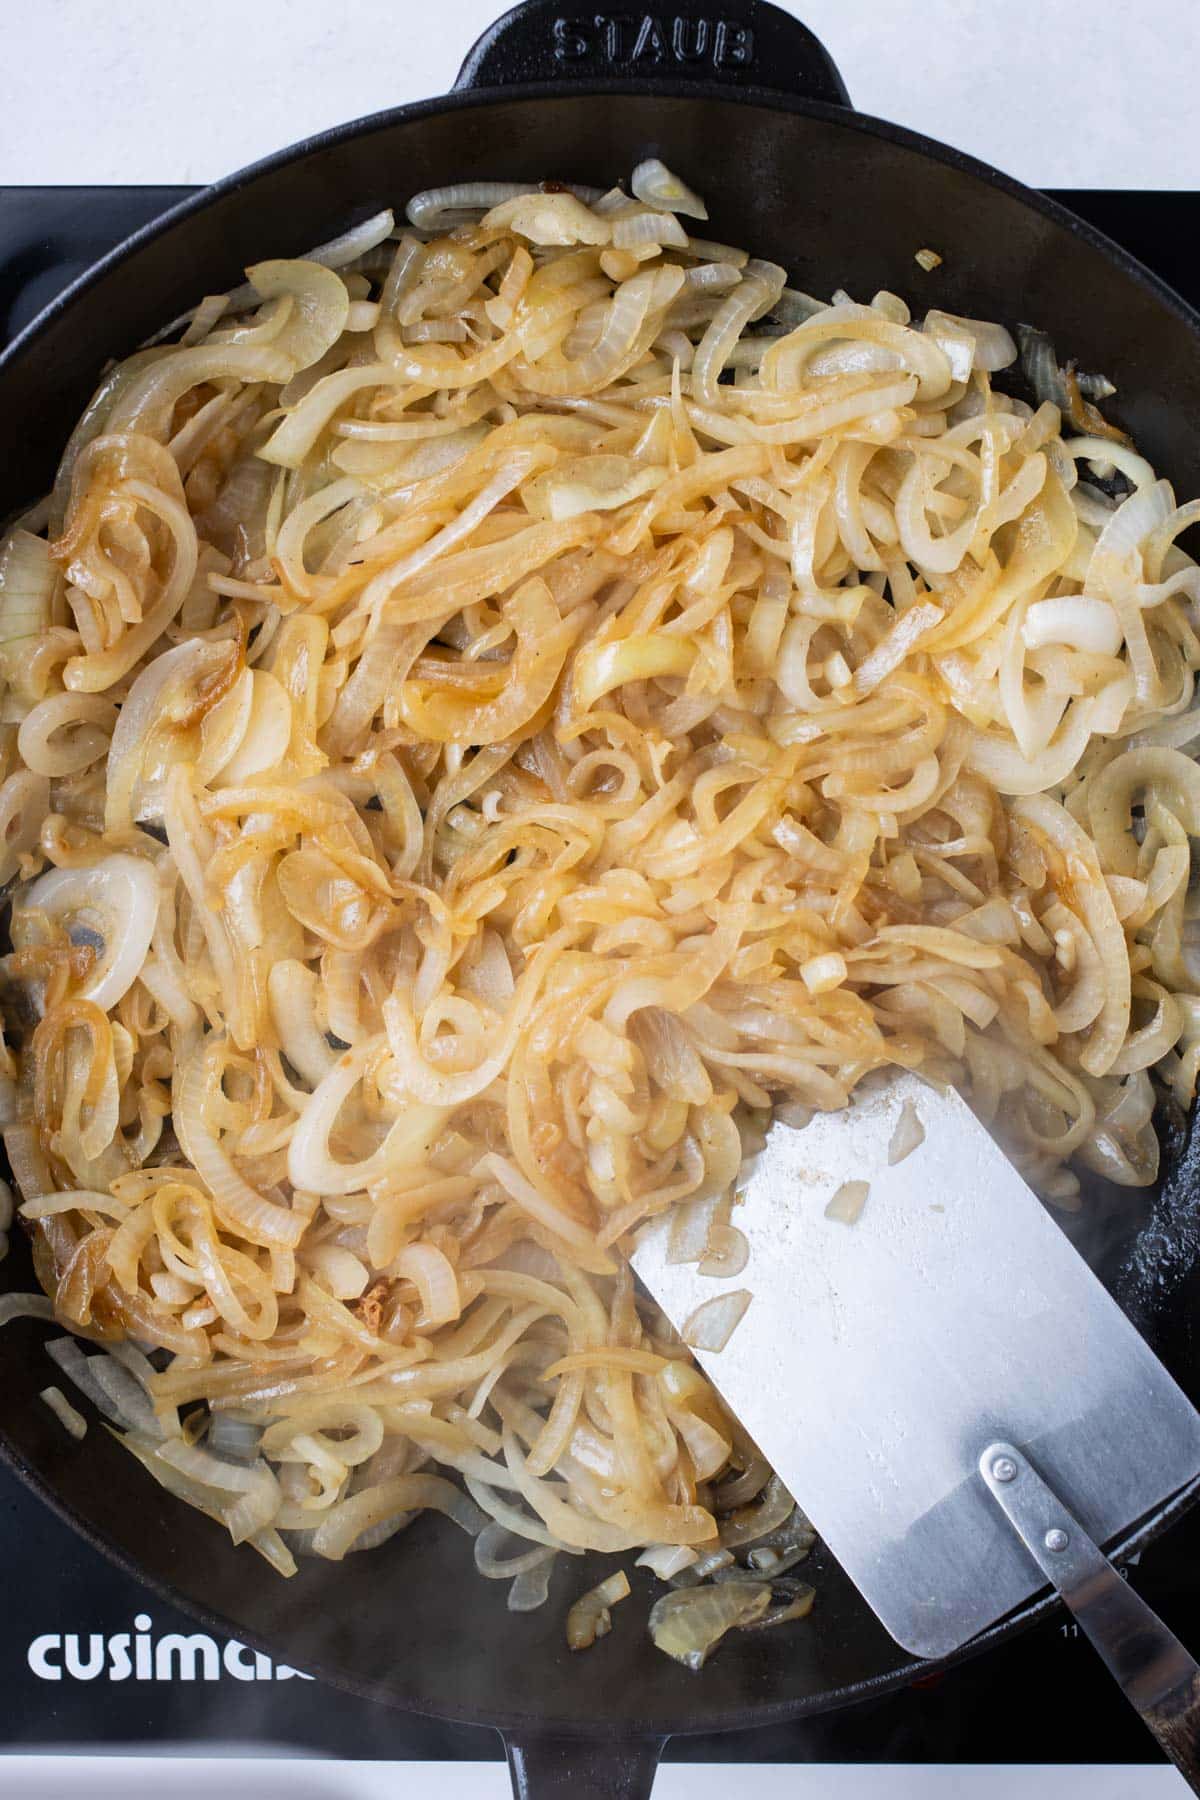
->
xmin=0 ymin=0 xmax=1200 ymax=187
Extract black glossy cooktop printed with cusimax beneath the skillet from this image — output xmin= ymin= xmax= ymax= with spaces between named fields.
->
xmin=0 ymin=187 xmax=1200 ymax=1786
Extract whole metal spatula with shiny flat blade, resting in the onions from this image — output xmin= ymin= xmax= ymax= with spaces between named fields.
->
xmin=633 ymin=1073 xmax=1200 ymax=1793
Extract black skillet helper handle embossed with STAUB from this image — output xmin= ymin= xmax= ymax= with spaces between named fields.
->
xmin=455 ymin=0 xmax=849 ymax=106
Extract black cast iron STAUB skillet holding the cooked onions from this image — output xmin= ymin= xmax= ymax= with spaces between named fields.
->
xmin=0 ymin=0 xmax=1200 ymax=1800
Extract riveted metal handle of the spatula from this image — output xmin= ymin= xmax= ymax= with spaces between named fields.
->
xmin=979 ymin=1444 xmax=1200 ymax=1795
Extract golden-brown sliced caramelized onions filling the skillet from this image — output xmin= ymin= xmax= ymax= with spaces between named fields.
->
xmin=0 ymin=158 xmax=1200 ymax=1665
